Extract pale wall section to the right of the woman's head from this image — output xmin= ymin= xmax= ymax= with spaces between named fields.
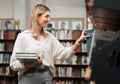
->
xmin=43 ymin=0 xmax=86 ymax=28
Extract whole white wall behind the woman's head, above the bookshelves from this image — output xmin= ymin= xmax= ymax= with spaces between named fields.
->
xmin=0 ymin=0 xmax=86 ymax=29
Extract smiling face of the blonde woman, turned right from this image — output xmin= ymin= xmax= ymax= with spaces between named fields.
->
xmin=38 ymin=11 xmax=50 ymax=28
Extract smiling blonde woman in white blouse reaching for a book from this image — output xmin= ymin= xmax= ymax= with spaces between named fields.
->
xmin=10 ymin=4 xmax=88 ymax=84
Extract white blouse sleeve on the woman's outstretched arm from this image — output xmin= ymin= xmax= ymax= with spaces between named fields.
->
xmin=53 ymin=36 xmax=75 ymax=60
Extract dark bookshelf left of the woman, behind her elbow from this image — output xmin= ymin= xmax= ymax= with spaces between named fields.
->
xmin=0 ymin=30 xmax=20 ymax=84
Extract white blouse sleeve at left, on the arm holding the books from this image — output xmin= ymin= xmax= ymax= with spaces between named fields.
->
xmin=10 ymin=33 xmax=25 ymax=71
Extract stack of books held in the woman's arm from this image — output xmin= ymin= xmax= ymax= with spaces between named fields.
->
xmin=16 ymin=53 xmax=38 ymax=63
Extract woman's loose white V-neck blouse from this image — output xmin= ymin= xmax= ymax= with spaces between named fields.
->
xmin=10 ymin=30 xmax=75 ymax=76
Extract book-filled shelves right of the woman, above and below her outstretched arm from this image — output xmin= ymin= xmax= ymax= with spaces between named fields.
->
xmin=47 ymin=29 xmax=88 ymax=84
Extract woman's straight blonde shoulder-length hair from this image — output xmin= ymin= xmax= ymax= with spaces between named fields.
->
xmin=30 ymin=4 xmax=50 ymax=37
